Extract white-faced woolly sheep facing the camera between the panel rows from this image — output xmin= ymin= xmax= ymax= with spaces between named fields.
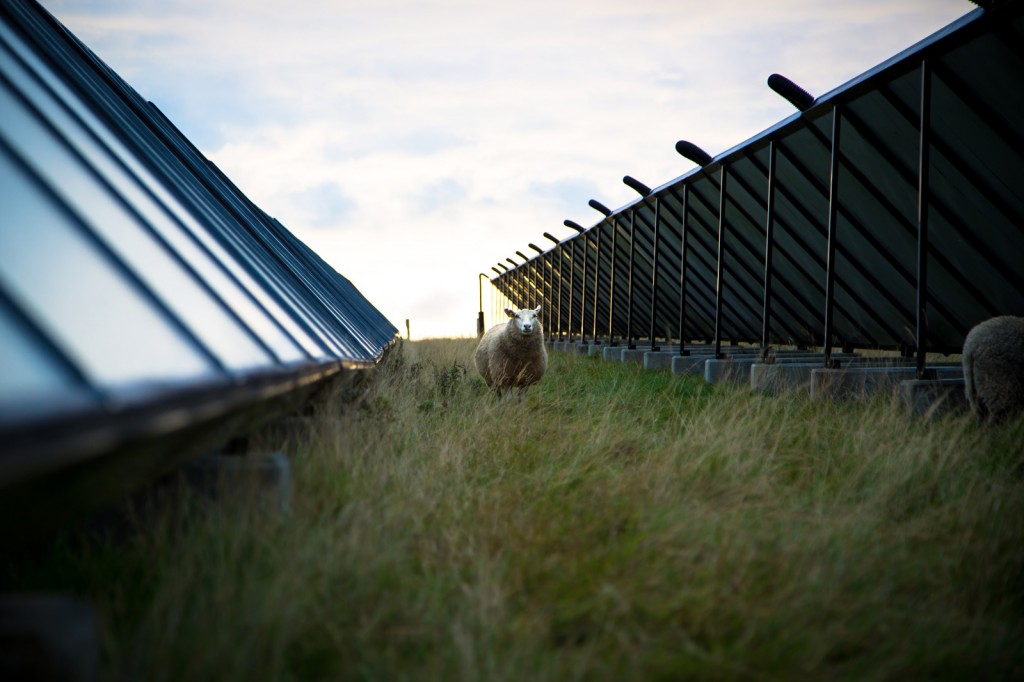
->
xmin=476 ymin=306 xmax=548 ymax=400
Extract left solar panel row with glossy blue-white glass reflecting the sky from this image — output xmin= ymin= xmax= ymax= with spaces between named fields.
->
xmin=0 ymin=0 xmax=397 ymax=509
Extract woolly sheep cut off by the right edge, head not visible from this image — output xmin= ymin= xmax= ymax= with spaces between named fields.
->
xmin=964 ymin=315 xmax=1024 ymax=423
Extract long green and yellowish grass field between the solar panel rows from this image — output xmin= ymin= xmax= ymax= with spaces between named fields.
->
xmin=0 ymin=340 xmax=1024 ymax=681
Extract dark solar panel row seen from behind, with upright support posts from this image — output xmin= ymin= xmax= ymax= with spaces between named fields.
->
xmin=492 ymin=0 xmax=1024 ymax=372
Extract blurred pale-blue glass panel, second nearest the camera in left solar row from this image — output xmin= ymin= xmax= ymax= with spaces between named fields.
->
xmin=0 ymin=148 xmax=215 ymax=386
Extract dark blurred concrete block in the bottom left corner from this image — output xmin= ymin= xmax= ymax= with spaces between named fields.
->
xmin=0 ymin=595 xmax=99 ymax=682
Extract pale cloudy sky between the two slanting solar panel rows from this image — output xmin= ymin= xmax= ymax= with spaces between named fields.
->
xmin=48 ymin=0 xmax=975 ymax=339
